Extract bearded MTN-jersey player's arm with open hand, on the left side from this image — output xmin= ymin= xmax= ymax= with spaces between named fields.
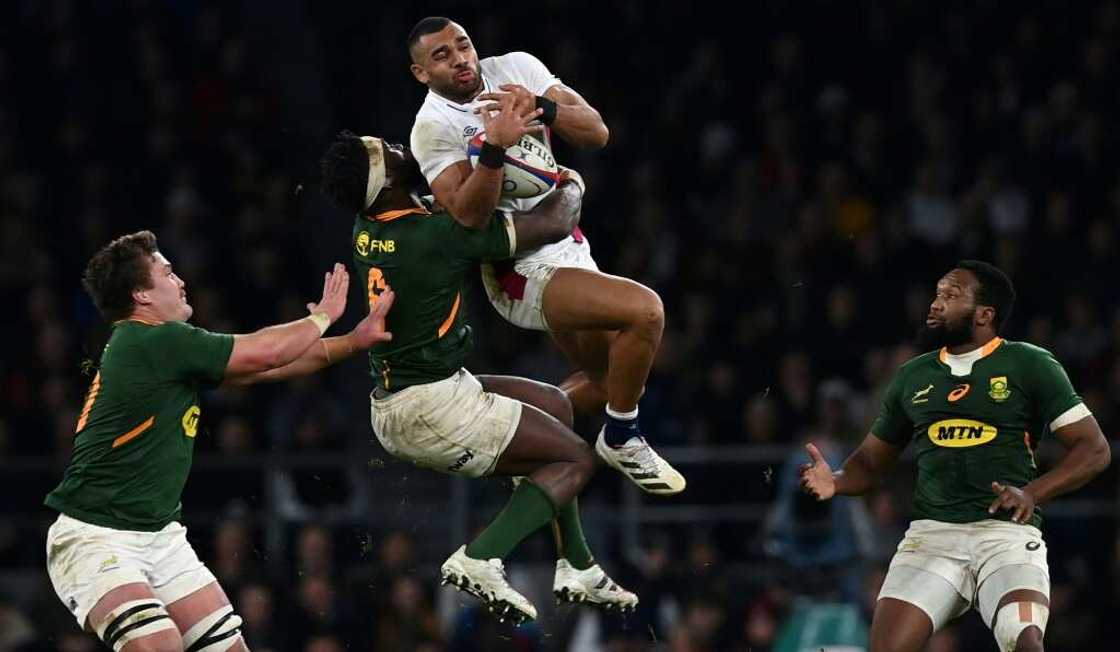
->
xmin=801 ymin=434 xmax=903 ymax=501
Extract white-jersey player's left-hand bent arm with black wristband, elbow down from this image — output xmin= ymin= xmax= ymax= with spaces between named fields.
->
xmin=431 ymin=100 xmax=544 ymax=229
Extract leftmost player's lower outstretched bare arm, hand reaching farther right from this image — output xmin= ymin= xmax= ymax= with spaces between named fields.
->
xmin=227 ymin=289 xmax=396 ymax=385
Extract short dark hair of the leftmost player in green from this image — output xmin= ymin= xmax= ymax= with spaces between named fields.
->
xmin=82 ymin=231 xmax=159 ymax=322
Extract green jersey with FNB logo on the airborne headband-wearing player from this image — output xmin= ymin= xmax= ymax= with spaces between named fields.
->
xmin=353 ymin=209 xmax=515 ymax=391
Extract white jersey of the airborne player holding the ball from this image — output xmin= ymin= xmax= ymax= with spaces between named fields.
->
xmin=410 ymin=52 xmax=586 ymax=263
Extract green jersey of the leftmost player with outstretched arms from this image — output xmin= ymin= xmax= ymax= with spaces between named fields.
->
xmin=44 ymin=320 xmax=233 ymax=532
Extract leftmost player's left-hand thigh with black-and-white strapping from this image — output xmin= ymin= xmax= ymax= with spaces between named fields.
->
xmin=87 ymin=581 xmax=184 ymax=652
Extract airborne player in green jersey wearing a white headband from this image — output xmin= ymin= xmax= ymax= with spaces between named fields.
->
xmin=321 ymin=125 xmax=637 ymax=622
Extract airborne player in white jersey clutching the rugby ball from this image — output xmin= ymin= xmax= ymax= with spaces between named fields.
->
xmin=409 ymin=18 xmax=685 ymax=494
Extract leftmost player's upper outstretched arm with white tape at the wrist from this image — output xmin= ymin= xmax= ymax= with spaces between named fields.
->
xmin=225 ymin=263 xmax=349 ymax=379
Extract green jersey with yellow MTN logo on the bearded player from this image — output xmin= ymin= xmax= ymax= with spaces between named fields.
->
xmin=871 ymin=337 xmax=1082 ymax=527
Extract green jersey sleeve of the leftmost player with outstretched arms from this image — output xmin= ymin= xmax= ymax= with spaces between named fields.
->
xmin=152 ymin=322 xmax=233 ymax=385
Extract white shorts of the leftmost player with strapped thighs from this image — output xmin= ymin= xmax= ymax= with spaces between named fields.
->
xmin=47 ymin=514 xmax=216 ymax=628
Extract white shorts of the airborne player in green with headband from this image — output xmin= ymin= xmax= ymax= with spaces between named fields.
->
xmin=370 ymin=369 xmax=522 ymax=477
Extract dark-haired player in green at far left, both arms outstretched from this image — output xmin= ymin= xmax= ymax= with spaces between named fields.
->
xmin=45 ymin=236 xmax=393 ymax=652
